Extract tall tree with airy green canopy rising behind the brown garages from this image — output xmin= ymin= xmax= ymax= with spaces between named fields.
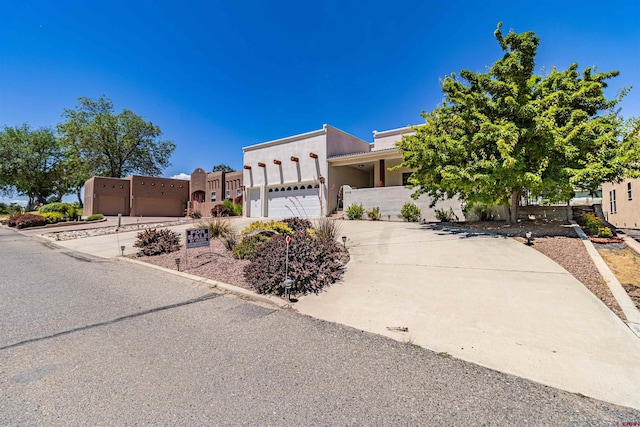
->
xmin=58 ymin=97 xmax=175 ymax=182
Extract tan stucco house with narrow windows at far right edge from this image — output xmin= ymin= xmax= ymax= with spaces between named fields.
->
xmin=602 ymin=178 xmax=640 ymax=228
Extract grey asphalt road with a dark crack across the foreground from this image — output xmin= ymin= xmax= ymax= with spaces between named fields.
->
xmin=0 ymin=228 xmax=640 ymax=426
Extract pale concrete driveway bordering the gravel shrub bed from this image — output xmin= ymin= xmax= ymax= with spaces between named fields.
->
xmin=13 ymin=219 xmax=640 ymax=409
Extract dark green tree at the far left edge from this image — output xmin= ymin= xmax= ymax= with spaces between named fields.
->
xmin=0 ymin=124 xmax=69 ymax=210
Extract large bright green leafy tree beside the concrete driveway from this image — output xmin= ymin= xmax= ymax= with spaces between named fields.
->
xmin=398 ymin=23 xmax=640 ymax=221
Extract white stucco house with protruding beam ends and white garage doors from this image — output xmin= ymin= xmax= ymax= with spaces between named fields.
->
xmin=243 ymin=125 xmax=464 ymax=220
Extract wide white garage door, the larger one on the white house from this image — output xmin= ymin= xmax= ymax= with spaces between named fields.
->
xmin=267 ymin=185 xmax=320 ymax=218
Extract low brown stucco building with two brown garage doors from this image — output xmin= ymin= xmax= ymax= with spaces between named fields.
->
xmin=84 ymin=175 xmax=189 ymax=216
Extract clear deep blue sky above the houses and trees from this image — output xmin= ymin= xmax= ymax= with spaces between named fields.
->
xmin=0 ymin=0 xmax=640 ymax=206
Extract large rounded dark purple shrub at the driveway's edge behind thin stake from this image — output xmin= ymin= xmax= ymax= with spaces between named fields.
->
xmin=244 ymin=231 xmax=345 ymax=295
